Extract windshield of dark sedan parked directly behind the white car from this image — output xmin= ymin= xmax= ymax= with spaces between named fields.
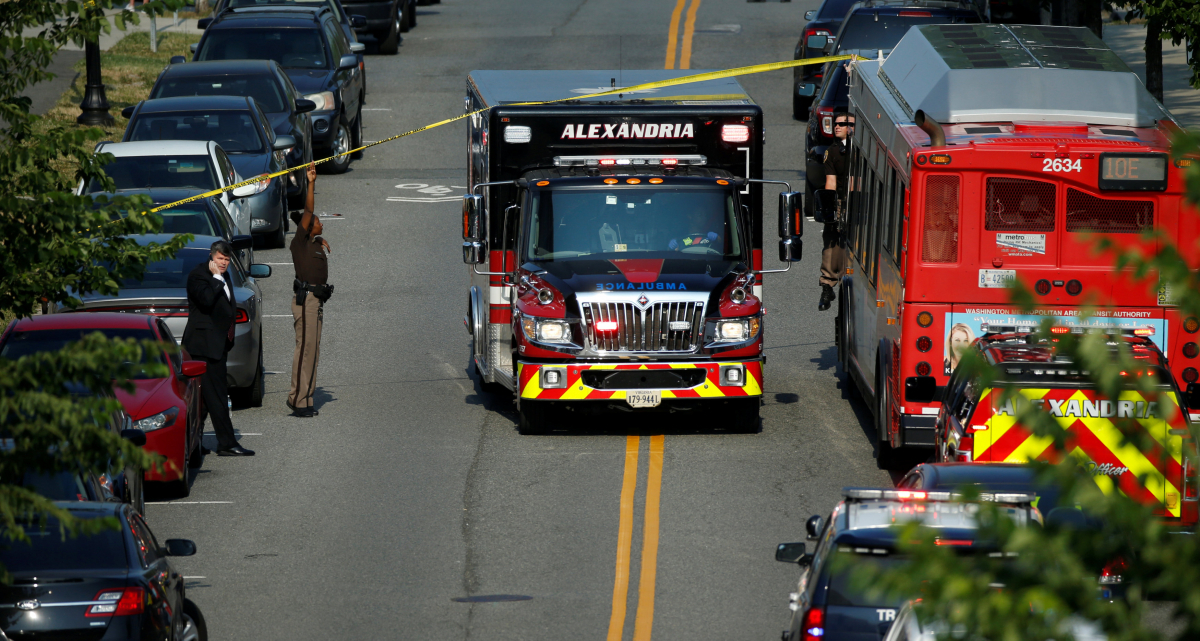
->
xmin=126 ymin=112 xmax=266 ymax=154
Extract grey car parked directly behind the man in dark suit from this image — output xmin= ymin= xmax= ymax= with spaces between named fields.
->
xmin=58 ymin=234 xmax=271 ymax=407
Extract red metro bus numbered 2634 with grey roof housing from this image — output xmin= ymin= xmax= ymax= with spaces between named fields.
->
xmin=835 ymin=24 xmax=1200 ymax=467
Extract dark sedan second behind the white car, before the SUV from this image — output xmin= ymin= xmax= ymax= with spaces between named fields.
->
xmin=150 ymin=60 xmax=317 ymax=211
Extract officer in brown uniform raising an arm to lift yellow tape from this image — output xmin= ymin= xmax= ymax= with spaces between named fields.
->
xmin=287 ymin=164 xmax=334 ymax=418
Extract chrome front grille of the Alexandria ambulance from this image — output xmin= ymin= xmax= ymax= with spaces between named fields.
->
xmin=581 ymin=301 xmax=704 ymax=353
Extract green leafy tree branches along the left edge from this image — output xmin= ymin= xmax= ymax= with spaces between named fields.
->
xmin=0 ymin=0 xmax=187 ymax=573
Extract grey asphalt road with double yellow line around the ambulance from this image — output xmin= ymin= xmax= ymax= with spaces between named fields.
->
xmin=148 ymin=0 xmax=889 ymax=641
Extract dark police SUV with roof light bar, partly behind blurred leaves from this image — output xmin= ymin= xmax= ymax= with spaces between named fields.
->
xmin=775 ymin=487 xmax=1039 ymax=641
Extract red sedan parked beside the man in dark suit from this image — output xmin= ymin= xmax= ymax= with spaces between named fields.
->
xmin=0 ymin=312 xmax=205 ymax=496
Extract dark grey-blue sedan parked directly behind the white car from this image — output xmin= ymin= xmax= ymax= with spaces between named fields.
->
xmin=121 ymin=96 xmax=296 ymax=247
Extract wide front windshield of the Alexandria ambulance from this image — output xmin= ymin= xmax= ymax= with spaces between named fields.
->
xmin=524 ymin=186 xmax=743 ymax=260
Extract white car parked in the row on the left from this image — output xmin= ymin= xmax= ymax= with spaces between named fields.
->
xmin=78 ymin=140 xmax=258 ymax=235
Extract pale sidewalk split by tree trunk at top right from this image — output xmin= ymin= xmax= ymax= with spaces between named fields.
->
xmin=1104 ymin=23 xmax=1200 ymax=131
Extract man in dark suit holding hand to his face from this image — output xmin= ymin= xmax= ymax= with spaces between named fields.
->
xmin=182 ymin=240 xmax=254 ymax=456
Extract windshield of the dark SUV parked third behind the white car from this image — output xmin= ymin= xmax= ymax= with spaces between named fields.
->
xmin=196 ymin=28 xmax=331 ymax=68
